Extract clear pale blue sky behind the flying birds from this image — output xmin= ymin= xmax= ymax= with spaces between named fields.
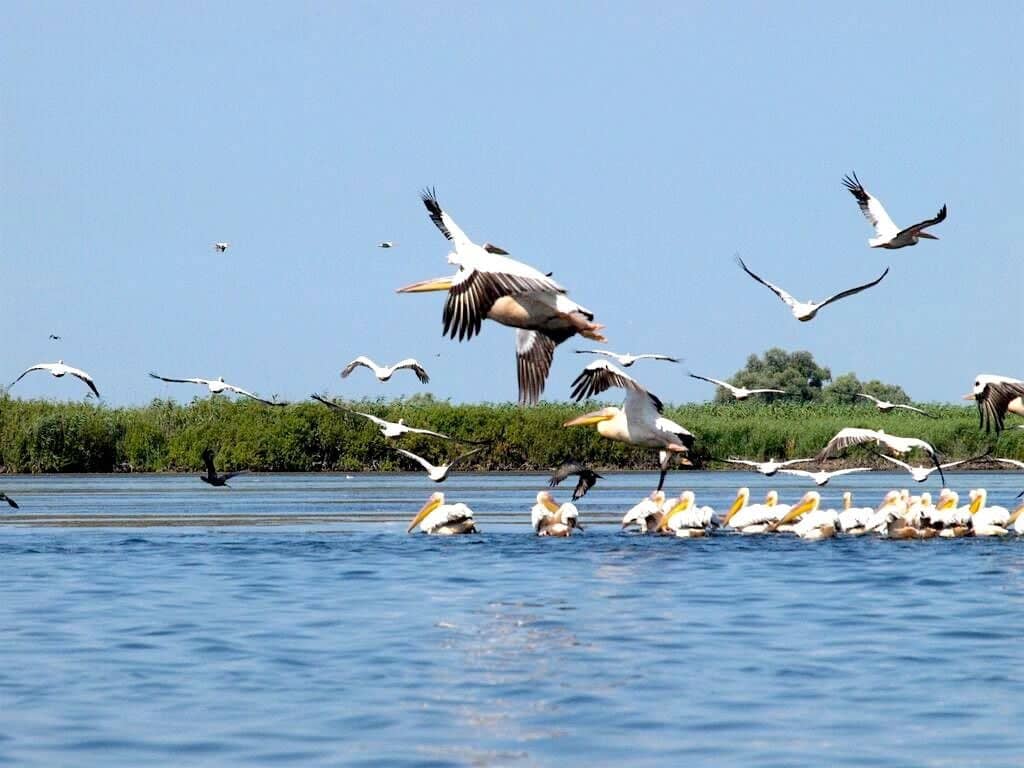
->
xmin=0 ymin=2 xmax=1024 ymax=404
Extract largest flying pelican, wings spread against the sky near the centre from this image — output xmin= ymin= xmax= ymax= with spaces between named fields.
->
xmin=398 ymin=190 xmax=605 ymax=404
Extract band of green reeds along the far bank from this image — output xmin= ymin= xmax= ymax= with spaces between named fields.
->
xmin=0 ymin=395 xmax=1024 ymax=472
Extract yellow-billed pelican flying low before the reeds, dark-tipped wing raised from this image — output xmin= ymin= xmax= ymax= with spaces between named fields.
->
xmin=562 ymin=360 xmax=693 ymax=490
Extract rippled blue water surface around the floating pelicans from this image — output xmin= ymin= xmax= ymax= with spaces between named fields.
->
xmin=0 ymin=473 xmax=1024 ymax=766
